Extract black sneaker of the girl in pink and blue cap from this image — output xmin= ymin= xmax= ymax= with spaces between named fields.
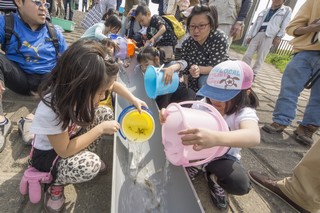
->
xmin=206 ymin=172 xmax=228 ymax=210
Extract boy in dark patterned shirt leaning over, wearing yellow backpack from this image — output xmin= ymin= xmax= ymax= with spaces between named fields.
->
xmin=135 ymin=2 xmax=177 ymax=60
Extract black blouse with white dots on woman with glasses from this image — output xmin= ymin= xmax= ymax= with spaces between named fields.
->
xmin=181 ymin=30 xmax=229 ymax=92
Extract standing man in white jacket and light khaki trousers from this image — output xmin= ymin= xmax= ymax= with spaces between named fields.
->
xmin=242 ymin=0 xmax=292 ymax=75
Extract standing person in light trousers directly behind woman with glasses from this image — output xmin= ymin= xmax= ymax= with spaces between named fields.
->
xmin=208 ymin=0 xmax=252 ymax=47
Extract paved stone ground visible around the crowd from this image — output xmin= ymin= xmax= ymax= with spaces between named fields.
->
xmin=0 ymin=11 xmax=320 ymax=213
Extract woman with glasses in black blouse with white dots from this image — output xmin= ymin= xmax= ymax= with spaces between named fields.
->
xmin=181 ymin=5 xmax=229 ymax=92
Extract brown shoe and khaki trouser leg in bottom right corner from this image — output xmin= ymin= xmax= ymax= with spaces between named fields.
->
xmin=249 ymin=140 xmax=320 ymax=212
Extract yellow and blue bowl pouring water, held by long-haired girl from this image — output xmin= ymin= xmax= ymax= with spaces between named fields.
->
xmin=118 ymin=106 xmax=155 ymax=142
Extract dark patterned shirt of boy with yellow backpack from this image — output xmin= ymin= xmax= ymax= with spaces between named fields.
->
xmin=147 ymin=15 xmax=177 ymax=46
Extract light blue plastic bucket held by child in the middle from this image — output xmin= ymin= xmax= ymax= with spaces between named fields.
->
xmin=144 ymin=65 xmax=179 ymax=99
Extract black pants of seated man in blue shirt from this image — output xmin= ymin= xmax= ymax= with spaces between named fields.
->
xmin=0 ymin=53 xmax=47 ymax=95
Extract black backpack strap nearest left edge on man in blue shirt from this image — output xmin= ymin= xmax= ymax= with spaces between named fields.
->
xmin=1 ymin=13 xmax=21 ymax=52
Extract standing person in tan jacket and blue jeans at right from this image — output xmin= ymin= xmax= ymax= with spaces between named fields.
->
xmin=262 ymin=0 xmax=320 ymax=146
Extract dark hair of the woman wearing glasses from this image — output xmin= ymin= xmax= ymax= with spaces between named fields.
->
xmin=187 ymin=5 xmax=219 ymax=31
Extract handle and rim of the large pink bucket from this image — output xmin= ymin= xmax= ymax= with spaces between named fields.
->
xmin=165 ymin=101 xmax=229 ymax=166
